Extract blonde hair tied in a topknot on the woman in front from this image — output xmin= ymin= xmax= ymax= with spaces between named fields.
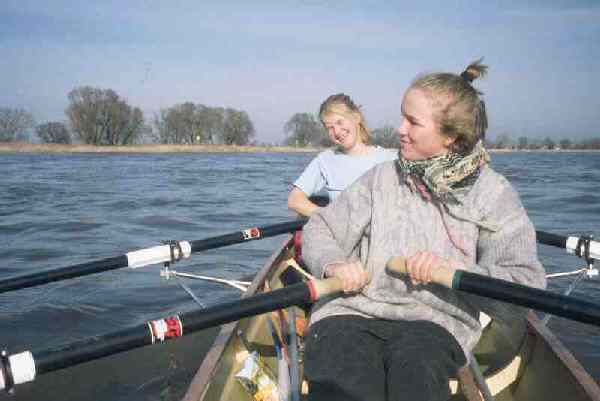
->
xmin=409 ymin=58 xmax=488 ymax=154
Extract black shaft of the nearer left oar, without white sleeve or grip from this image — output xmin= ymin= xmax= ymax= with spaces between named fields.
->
xmin=9 ymin=283 xmax=314 ymax=382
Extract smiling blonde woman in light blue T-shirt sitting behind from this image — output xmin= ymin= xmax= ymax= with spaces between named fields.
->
xmin=288 ymin=93 xmax=398 ymax=216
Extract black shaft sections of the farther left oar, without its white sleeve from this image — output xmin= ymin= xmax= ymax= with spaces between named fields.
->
xmin=0 ymin=220 xmax=306 ymax=294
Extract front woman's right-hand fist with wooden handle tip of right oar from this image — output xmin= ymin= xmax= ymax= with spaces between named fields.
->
xmin=387 ymin=251 xmax=458 ymax=288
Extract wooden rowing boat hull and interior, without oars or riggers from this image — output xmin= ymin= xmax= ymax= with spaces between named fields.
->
xmin=184 ymin=236 xmax=600 ymax=401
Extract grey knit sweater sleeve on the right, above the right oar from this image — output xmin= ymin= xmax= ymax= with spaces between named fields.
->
xmin=469 ymin=180 xmax=546 ymax=288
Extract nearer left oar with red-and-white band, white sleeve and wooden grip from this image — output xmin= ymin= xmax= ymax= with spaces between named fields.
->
xmin=0 ymin=278 xmax=343 ymax=390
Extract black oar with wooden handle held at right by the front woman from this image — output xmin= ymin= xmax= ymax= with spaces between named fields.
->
xmin=387 ymin=257 xmax=600 ymax=326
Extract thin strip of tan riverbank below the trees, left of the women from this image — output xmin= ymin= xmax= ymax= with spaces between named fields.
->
xmin=0 ymin=142 xmax=320 ymax=153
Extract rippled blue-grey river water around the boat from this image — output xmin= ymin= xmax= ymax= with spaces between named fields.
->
xmin=0 ymin=152 xmax=600 ymax=401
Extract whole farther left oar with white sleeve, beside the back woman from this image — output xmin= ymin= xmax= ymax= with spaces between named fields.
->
xmin=0 ymin=220 xmax=306 ymax=294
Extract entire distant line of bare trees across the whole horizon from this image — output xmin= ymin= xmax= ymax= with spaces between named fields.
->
xmin=0 ymin=90 xmax=600 ymax=150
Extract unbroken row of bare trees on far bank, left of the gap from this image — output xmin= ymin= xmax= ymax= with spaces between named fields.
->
xmin=0 ymin=86 xmax=255 ymax=145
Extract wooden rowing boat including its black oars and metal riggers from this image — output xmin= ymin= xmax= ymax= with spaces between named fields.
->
xmin=0 ymin=221 xmax=600 ymax=401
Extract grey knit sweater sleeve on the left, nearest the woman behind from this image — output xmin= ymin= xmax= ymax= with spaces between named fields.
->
xmin=302 ymin=169 xmax=377 ymax=277
